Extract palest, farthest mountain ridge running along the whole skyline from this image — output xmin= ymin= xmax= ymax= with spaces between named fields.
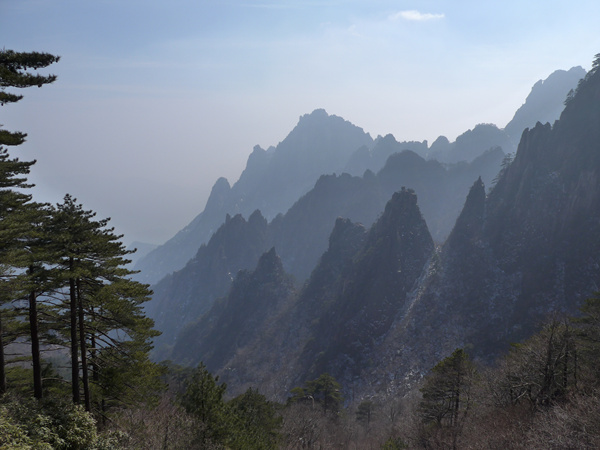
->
xmin=135 ymin=67 xmax=585 ymax=284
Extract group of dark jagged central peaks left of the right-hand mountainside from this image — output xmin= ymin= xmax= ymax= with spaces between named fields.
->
xmin=174 ymin=189 xmax=434 ymax=398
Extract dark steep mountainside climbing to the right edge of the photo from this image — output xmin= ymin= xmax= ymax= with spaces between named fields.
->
xmin=371 ymin=61 xmax=600 ymax=398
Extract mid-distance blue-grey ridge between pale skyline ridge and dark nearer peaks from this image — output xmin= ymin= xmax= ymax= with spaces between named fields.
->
xmin=147 ymin=145 xmax=504 ymax=357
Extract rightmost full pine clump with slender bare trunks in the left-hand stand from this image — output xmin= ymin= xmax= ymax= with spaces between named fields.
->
xmin=52 ymin=195 xmax=158 ymax=410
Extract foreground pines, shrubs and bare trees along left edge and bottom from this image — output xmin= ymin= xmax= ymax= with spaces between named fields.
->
xmin=0 ymin=45 xmax=600 ymax=450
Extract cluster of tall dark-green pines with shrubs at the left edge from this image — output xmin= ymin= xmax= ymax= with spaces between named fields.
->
xmin=0 ymin=50 xmax=162 ymax=448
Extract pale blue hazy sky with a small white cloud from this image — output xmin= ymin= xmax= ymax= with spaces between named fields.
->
xmin=0 ymin=0 xmax=600 ymax=243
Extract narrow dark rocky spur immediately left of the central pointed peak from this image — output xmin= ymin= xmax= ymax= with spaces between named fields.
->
xmin=211 ymin=218 xmax=367 ymax=400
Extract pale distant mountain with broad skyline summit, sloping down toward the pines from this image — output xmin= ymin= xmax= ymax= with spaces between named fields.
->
xmin=135 ymin=109 xmax=372 ymax=284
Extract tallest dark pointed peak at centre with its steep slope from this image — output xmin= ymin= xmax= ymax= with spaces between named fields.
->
xmin=301 ymin=189 xmax=434 ymax=382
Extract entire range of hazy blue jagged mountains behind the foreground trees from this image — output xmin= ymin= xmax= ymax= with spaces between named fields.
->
xmin=138 ymin=65 xmax=600 ymax=398
